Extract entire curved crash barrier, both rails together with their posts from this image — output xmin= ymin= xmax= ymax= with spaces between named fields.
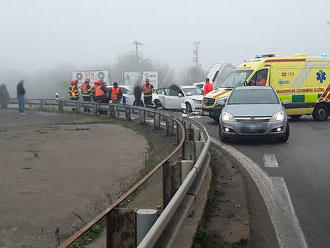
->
xmin=10 ymin=99 xmax=210 ymax=248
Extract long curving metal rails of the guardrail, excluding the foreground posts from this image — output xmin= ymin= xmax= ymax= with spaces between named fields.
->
xmin=10 ymin=99 xmax=210 ymax=248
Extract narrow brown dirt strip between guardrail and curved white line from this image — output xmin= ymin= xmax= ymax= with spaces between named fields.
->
xmin=195 ymin=148 xmax=250 ymax=248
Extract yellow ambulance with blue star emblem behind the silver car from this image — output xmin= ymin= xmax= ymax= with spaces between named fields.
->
xmin=203 ymin=54 xmax=330 ymax=121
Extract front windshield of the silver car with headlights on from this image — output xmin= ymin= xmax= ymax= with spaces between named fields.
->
xmin=228 ymin=89 xmax=279 ymax=105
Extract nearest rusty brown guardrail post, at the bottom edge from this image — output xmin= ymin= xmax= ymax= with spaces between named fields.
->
xmin=106 ymin=208 xmax=135 ymax=248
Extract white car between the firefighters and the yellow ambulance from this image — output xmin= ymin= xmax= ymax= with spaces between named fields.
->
xmin=153 ymin=86 xmax=203 ymax=112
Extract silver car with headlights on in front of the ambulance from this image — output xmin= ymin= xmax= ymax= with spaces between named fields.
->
xmin=219 ymin=86 xmax=290 ymax=142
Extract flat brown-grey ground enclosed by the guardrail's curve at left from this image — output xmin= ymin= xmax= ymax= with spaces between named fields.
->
xmin=0 ymin=109 xmax=148 ymax=248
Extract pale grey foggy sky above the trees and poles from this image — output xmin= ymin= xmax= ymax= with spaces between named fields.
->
xmin=0 ymin=0 xmax=330 ymax=70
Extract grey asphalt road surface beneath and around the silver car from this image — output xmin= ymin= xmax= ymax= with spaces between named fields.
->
xmin=196 ymin=116 xmax=330 ymax=248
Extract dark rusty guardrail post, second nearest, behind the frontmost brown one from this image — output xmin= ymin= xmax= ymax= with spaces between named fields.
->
xmin=163 ymin=161 xmax=181 ymax=209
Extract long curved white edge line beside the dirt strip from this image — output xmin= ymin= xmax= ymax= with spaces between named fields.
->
xmin=211 ymin=138 xmax=308 ymax=248
